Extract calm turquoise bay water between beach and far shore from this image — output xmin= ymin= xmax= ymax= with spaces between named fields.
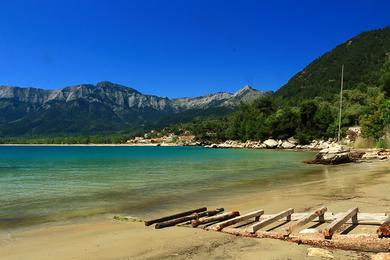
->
xmin=0 ymin=146 xmax=318 ymax=228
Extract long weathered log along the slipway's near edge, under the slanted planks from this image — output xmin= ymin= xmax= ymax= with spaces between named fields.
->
xmin=221 ymin=227 xmax=390 ymax=253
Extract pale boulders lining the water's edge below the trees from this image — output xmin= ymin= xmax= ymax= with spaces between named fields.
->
xmin=204 ymin=137 xmax=390 ymax=164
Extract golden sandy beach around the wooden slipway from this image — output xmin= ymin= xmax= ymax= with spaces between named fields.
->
xmin=0 ymin=161 xmax=390 ymax=259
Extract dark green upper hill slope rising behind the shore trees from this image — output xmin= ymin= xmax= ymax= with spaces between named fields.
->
xmin=275 ymin=27 xmax=390 ymax=99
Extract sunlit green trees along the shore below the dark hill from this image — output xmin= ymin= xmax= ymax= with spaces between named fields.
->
xmin=170 ymin=60 xmax=390 ymax=148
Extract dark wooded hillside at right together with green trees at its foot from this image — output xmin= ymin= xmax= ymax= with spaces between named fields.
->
xmin=173 ymin=27 xmax=390 ymax=147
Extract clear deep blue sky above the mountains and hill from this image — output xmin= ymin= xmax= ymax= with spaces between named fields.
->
xmin=0 ymin=0 xmax=390 ymax=97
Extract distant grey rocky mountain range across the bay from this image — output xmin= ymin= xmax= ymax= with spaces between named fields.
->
xmin=0 ymin=81 xmax=270 ymax=136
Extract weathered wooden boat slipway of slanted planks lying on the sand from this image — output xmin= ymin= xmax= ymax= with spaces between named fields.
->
xmin=145 ymin=207 xmax=390 ymax=252
